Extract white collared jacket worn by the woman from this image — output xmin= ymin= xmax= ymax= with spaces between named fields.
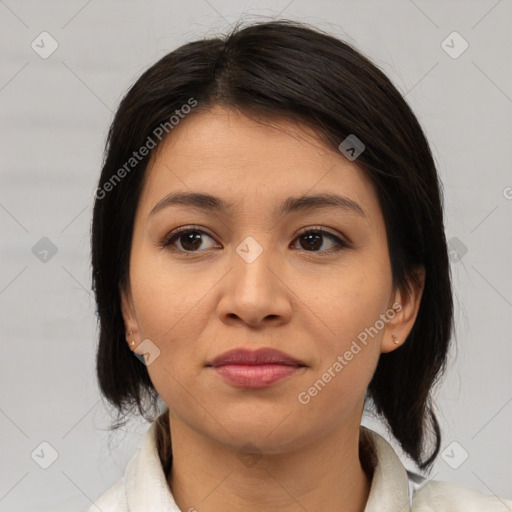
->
xmin=87 ymin=422 xmax=512 ymax=512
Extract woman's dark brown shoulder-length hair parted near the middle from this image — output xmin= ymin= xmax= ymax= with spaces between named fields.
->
xmin=91 ymin=20 xmax=453 ymax=469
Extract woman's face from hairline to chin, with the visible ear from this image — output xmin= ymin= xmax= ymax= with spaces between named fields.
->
xmin=123 ymin=107 xmax=424 ymax=453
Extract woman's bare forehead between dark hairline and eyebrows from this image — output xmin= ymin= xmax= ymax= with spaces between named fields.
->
xmin=136 ymin=107 xmax=379 ymax=222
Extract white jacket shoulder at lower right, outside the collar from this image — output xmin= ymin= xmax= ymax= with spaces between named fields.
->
xmin=412 ymin=480 xmax=512 ymax=512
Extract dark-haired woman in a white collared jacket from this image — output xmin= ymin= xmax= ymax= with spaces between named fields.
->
xmin=90 ymin=21 xmax=512 ymax=512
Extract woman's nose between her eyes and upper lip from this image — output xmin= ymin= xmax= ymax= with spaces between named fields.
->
xmin=217 ymin=241 xmax=293 ymax=327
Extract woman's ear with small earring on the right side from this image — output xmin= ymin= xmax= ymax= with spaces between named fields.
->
xmin=381 ymin=266 xmax=425 ymax=353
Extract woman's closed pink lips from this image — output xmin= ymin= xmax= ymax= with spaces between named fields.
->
xmin=206 ymin=348 xmax=306 ymax=389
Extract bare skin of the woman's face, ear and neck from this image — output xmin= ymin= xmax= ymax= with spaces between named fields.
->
xmin=121 ymin=106 xmax=425 ymax=512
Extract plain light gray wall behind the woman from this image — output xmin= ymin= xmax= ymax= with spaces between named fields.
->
xmin=0 ymin=0 xmax=512 ymax=512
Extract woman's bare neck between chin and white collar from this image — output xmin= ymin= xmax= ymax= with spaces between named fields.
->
xmin=167 ymin=417 xmax=370 ymax=512
